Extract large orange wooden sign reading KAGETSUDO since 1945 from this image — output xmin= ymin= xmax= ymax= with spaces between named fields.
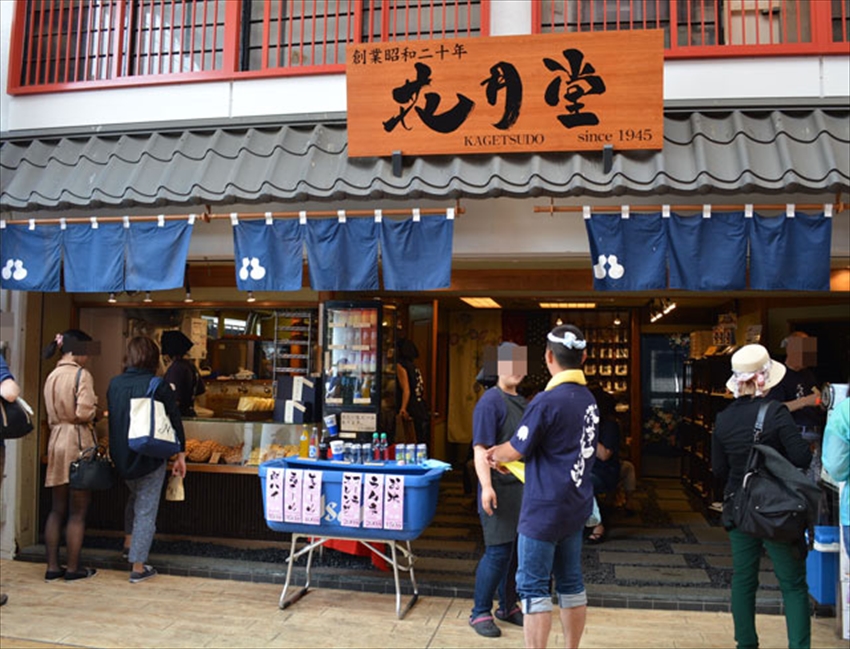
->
xmin=346 ymin=29 xmax=664 ymax=157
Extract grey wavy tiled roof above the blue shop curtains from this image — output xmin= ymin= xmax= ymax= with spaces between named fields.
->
xmin=0 ymin=108 xmax=850 ymax=212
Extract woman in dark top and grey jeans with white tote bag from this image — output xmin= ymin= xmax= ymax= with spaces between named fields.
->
xmin=106 ymin=336 xmax=186 ymax=584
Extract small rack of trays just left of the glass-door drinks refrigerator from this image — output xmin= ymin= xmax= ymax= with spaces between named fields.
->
xmin=266 ymin=310 xmax=318 ymax=380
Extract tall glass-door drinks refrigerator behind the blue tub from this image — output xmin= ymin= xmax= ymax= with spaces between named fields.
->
xmin=322 ymin=301 xmax=396 ymax=440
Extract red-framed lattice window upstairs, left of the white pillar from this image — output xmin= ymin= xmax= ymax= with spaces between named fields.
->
xmin=10 ymin=0 xmax=490 ymax=92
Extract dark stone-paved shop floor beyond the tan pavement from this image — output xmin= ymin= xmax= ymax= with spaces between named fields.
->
xmin=13 ymin=471 xmax=832 ymax=613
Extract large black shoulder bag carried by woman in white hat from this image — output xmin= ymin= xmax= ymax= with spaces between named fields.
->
xmin=731 ymin=403 xmax=820 ymax=543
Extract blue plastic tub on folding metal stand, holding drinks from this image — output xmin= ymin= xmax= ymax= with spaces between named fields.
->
xmin=258 ymin=458 xmax=445 ymax=541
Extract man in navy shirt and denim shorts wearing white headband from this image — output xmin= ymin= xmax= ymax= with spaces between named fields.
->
xmin=487 ymin=325 xmax=599 ymax=647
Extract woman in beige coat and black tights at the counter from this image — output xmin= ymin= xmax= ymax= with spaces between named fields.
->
xmin=43 ymin=329 xmax=97 ymax=581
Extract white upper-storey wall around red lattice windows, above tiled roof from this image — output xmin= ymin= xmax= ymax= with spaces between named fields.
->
xmin=0 ymin=0 xmax=850 ymax=132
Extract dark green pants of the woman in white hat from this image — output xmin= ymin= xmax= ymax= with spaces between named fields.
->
xmin=729 ymin=529 xmax=812 ymax=649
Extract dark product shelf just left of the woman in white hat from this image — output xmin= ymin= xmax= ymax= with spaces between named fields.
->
xmin=680 ymin=356 xmax=732 ymax=506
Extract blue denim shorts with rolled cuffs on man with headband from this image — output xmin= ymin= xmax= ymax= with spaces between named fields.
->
xmin=516 ymin=530 xmax=587 ymax=613
